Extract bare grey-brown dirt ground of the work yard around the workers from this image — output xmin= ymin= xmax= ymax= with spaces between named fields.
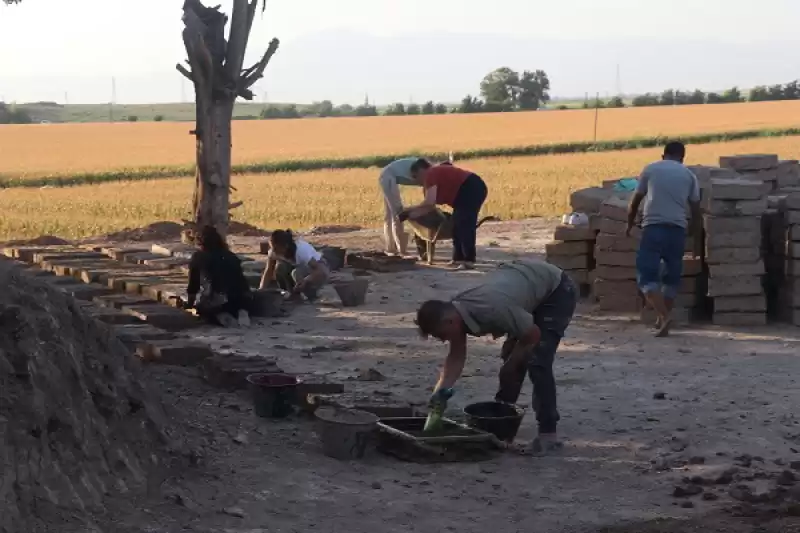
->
xmin=83 ymin=220 xmax=800 ymax=533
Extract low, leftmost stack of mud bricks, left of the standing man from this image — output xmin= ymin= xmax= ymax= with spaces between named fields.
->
xmin=545 ymin=224 xmax=595 ymax=290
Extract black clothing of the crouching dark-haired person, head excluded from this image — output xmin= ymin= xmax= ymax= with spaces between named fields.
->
xmin=187 ymin=249 xmax=252 ymax=325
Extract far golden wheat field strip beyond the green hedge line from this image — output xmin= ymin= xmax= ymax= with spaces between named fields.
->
xmin=0 ymin=101 xmax=800 ymax=180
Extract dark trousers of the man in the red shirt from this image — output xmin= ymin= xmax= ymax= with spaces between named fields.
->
xmin=453 ymin=174 xmax=489 ymax=263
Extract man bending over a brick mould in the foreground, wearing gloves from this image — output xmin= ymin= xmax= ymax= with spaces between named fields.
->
xmin=416 ymin=259 xmax=578 ymax=453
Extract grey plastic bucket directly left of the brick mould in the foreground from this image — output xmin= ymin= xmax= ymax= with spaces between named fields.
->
xmin=315 ymin=407 xmax=379 ymax=461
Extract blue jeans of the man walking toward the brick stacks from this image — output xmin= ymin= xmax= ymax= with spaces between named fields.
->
xmin=636 ymin=224 xmax=686 ymax=299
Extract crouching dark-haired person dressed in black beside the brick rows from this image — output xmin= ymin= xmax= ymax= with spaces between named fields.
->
xmin=186 ymin=226 xmax=252 ymax=327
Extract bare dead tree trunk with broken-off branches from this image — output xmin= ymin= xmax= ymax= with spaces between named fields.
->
xmin=177 ymin=0 xmax=278 ymax=236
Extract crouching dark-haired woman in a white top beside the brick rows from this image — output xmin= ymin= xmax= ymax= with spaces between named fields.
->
xmin=261 ymin=229 xmax=330 ymax=302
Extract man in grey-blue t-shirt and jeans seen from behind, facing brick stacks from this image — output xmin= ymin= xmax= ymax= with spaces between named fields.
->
xmin=626 ymin=142 xmax=701 ymax=337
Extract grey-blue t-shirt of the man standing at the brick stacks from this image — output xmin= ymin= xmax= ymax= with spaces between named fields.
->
xmin=636 ymin=160 xmax=700 ymax=228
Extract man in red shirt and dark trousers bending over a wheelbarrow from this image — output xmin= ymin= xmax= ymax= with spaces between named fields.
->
xmin=404 ymin=159 xmax=488 ymax=268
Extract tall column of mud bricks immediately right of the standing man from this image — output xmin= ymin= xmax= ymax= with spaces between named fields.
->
xmin=703 ymin=168 xmax=777 ymax=326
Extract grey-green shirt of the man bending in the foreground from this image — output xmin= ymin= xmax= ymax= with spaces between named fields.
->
xmin=453 ymin=259 xmax=562 ymax=338
